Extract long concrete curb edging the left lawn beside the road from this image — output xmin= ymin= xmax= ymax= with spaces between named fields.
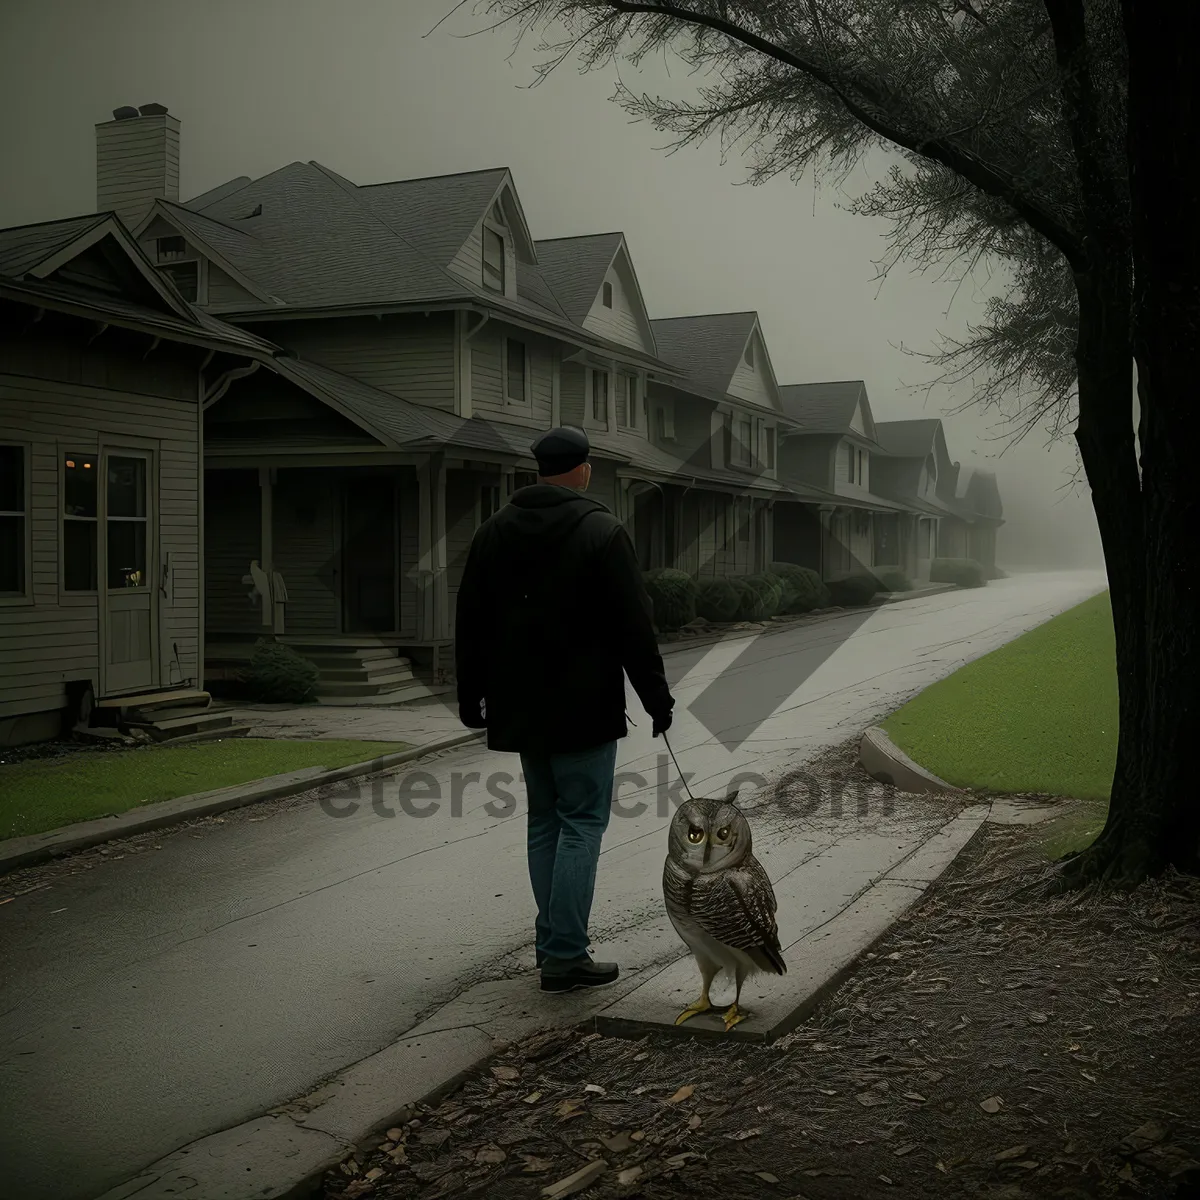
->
xmin=0 ymin=730 xmax=485 ymax=875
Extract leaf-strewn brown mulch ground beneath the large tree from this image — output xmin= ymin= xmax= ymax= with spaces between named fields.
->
xmin=322 ymin=827 xmax=1200 ymax=1200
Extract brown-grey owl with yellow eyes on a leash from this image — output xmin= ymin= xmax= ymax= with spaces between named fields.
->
xmin=662 ymin=792 xmax=787 ymax=1033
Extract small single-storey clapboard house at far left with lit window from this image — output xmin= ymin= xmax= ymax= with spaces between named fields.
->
xmin=0 ymin=212 xmax=271 ymax=745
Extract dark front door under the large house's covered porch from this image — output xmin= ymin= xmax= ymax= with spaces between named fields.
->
xmin=342 ymin=475 xmax=400 ymax=634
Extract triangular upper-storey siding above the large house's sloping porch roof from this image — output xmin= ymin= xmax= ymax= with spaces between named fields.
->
xmin=260 ymin=313 xmax=455 ymax=412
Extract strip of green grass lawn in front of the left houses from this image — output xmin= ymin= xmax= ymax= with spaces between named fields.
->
xmin=0 ymin=738 xmax=408 ymax=839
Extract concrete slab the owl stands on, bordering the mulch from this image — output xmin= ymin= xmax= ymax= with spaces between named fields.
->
xmin=595 ymin=805 xmax=988 ymax=1042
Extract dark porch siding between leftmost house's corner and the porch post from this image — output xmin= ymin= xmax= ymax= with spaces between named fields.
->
xmin=204 ymin=468 xmax=262 ymax=640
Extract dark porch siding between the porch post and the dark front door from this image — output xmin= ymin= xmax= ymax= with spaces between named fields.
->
xmin=271 ymin=467 xmax=342 ymax=634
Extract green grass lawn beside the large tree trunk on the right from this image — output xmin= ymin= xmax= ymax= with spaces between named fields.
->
xmin=883 ymin=592 xmax=1117 ymax=801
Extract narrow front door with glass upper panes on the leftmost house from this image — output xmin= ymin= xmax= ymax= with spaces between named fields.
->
xmin=100 ymin=446 xmax=158 ymax=695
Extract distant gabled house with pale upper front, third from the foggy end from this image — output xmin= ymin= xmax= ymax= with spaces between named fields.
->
xmin=775 ymin=379 xmax=906 ymax=580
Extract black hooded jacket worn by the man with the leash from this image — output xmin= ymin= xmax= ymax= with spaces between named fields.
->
xmin=455 ymin=484 xmax=674 ymax=754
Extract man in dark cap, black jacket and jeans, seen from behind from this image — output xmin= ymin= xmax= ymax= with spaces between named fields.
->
xmin=455 ymin=426 xmax=674 ymax=991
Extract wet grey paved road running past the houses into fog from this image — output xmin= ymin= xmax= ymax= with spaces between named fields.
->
xmin=0 ymin=572 xmax=1104 ymax=1200
